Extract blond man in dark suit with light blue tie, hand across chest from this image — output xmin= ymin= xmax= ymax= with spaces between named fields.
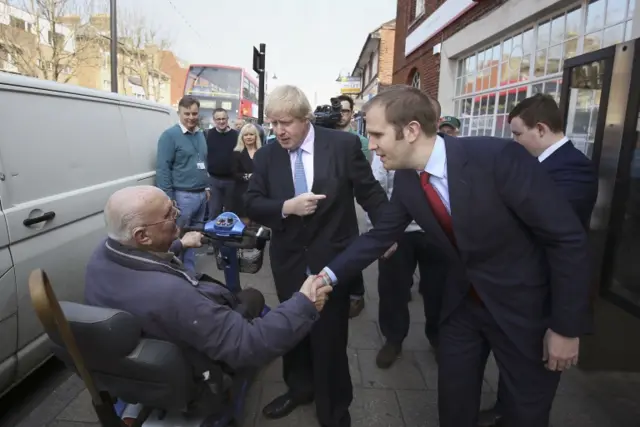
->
xmin=245 ymin=86 xmax=384 ymax=427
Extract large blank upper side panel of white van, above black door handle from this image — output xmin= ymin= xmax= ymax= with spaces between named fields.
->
xmin=0 ymin=91 xmax=131 ymax=208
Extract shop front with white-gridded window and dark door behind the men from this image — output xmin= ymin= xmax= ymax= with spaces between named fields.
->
xmin=438 ymin=0 xmax=640 ymax=371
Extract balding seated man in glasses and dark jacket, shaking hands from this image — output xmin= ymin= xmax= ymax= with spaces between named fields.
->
xmin=85 ymin=186 xmax=330 ymax=392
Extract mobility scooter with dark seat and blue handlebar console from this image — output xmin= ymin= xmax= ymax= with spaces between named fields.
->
xmin=29 ymin=212 xmax=270 ymax=427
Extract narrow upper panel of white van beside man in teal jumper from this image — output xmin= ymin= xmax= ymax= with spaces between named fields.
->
xmin=120 ymin=106 xmax=175 ymax=174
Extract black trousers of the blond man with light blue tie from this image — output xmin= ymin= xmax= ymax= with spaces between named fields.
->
xmin=282 ymin=283 xmax=353 ymax=427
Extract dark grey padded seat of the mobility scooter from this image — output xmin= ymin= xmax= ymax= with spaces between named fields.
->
xmin=49 ymin=302 xmax=202 ymax=411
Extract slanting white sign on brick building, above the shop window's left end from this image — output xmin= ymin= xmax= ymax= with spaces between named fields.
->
xmin=404 ymin=0 xmax=477 ymax=56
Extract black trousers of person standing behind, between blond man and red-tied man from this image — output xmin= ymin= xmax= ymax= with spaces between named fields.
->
xmin=378 ymin=231 xmax=442 ymax=345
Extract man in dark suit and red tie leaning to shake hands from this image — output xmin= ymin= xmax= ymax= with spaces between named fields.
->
xmin=317 ymin=86 xmax=589 ymax=427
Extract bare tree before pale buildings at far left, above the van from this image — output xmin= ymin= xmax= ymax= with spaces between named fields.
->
xmin=0 ymin=0 xmax=99 ymax=83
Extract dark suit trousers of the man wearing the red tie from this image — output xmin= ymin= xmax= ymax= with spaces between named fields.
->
xmin=438 ymin=298 xmax=560 ymax=427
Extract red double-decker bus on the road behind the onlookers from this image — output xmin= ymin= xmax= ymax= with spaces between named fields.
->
xmin=184 ymin=64 xmax=258 ymax=129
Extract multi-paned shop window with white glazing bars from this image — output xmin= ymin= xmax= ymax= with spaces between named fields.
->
xmin=454 ymin=0 xmax=635 ymax=137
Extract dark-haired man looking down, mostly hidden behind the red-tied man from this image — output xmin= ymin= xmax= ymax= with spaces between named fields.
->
xmin=479 ymin=93 xmax=598 ymax=426
